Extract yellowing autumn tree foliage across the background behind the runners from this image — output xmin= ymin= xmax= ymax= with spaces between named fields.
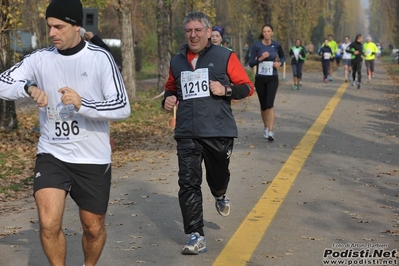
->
xmin=6 ymin=0 xmax=399 ymax=69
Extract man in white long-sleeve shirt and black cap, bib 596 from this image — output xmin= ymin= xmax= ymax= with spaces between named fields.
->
xmin=0 ymin=0 xmax=130 ymax=266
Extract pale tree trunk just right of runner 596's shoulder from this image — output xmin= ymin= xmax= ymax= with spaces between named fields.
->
xmin=117 ymin=0 xmax=137 ymax=99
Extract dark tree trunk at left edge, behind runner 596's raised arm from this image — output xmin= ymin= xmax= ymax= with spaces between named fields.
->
xmin=0 ymin=0 xmax=18 ymax=131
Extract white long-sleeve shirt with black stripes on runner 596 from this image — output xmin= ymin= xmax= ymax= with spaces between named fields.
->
xmin=0 ymin=42 xmax=130 ymax=164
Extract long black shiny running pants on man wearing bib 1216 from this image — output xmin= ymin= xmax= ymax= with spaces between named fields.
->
xmin=176 ymin=138 xmax=234 ymax=235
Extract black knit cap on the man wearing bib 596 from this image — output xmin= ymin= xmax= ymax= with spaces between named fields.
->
xmin=46 ymin=0 xmax=83 ymax=26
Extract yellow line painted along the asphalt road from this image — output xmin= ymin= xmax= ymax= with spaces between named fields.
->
xmin=213 ymin=83 xmax=348 ymax=266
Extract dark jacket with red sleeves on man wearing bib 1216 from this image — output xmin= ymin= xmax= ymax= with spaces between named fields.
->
xmin=162 ymin=41 xmax=254 ymax=138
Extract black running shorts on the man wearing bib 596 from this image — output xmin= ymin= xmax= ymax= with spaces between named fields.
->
xmin=33 ymin=154 xmax=111 ymax=214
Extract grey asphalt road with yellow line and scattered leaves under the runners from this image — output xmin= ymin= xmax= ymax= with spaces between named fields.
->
xmin=0 ymin=59 xmax=399 ymax=266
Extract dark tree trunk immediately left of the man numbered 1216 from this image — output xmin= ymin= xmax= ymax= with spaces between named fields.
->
xmin=157 ymin=0 xmax=172 ymax=91
